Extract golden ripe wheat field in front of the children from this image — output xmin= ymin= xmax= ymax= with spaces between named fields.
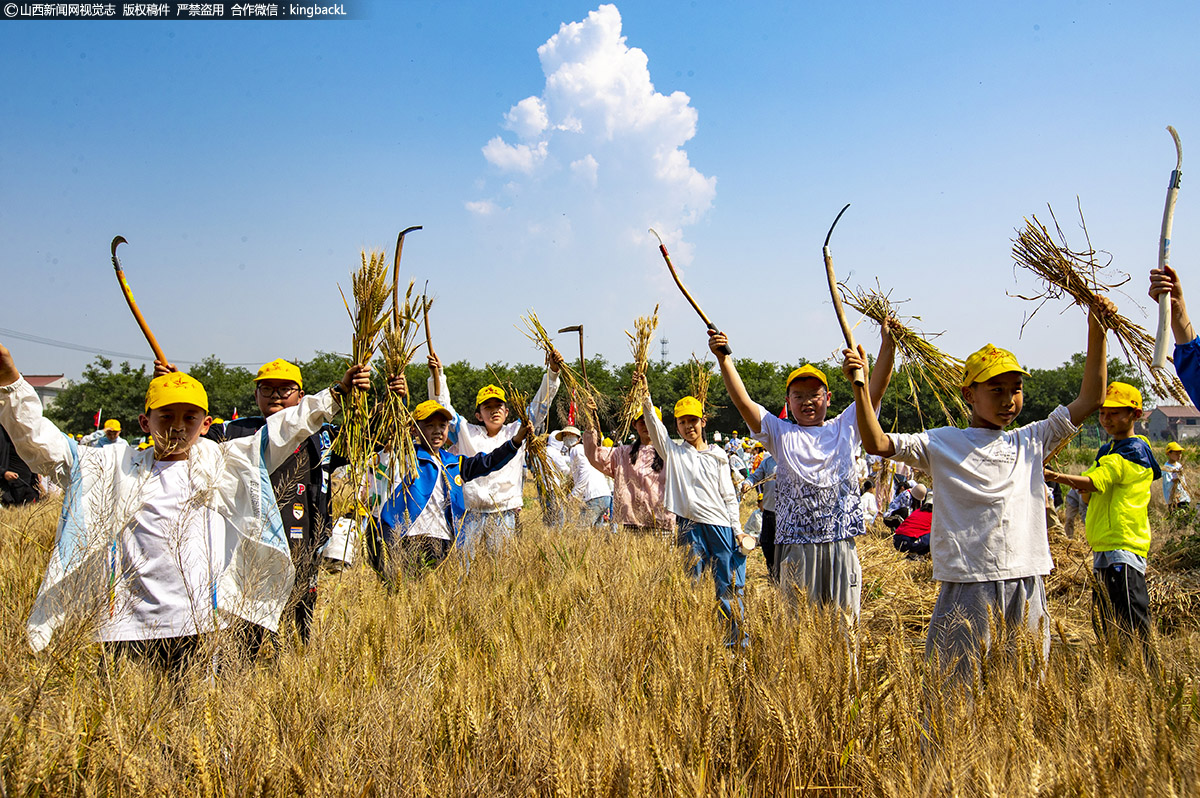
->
xmin=0 ymin=451 xmax=1200 ymax=797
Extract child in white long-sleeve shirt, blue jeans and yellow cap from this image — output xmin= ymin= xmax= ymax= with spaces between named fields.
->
xmin=634 ymin=374 xmax=754 ymax=647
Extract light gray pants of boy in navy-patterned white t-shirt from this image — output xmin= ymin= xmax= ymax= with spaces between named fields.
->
xmin=775 ymin=538 xmax=863 ymax=623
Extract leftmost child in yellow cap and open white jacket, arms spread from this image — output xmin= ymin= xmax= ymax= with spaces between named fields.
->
xmin=0 ymin=338 xmax=371 ymax=667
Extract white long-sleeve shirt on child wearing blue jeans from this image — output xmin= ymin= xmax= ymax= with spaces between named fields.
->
xmin=642 ymin=391 xmax=742 ymax=533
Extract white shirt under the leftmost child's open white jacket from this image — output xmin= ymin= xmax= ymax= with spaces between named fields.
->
xmin=104 ymin=460 xmax=236 ymax=641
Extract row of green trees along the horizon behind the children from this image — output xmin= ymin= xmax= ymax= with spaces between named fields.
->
xmin=47 ymin=352 xmax=1142 ymax=436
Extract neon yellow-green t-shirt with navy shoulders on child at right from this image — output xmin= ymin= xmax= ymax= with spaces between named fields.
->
xmin=1084 ymin=436 xmax=1162 ymax=557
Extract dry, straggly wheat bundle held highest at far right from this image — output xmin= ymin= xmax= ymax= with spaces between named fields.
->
xmin=1013 ymin=209 xmax=1190 ymax=404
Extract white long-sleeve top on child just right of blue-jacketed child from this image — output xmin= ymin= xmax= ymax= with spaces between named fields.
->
xmin=428 ymin=370 xmax=558 ymax=512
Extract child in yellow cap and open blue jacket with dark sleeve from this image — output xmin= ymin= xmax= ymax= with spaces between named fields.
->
xmin=374 ymin=376 xmax=529 ymax=578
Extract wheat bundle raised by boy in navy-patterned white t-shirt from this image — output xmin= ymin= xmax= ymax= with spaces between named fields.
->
xmin=839 ymin=284 xmax=968 ymax=426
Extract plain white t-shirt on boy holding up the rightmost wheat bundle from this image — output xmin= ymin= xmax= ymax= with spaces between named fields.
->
xmin=888 ymin=406 xmax=1076 ymax=582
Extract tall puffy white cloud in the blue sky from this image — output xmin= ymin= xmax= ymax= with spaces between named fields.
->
xmin=468 ymin=5 xmax=716 ymax=267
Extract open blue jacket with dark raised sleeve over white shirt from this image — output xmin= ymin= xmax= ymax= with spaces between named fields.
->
xmin=379 ymin=440 xmax=520 ymax=544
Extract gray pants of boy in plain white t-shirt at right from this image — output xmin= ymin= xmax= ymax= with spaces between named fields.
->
xmin=925 ymin=576 xmax=1050 ymax=682
